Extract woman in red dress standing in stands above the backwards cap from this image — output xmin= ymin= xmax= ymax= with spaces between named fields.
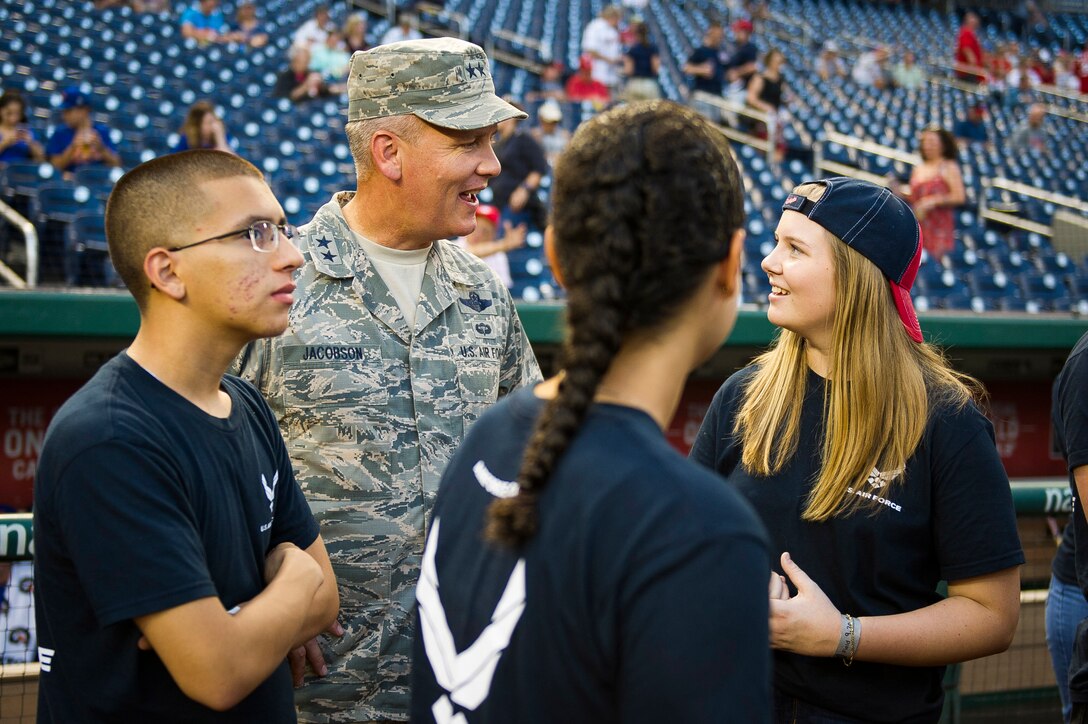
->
xmin=902 ymin=126 xmax=967 ymax=261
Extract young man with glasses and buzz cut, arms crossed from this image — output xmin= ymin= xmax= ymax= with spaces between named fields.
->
xmin=34 ymin=150 xmax=338 ymax=724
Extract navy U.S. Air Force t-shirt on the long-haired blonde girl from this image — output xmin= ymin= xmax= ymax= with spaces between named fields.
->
xmin=691 ymin=366 xmax=1024 ymax=722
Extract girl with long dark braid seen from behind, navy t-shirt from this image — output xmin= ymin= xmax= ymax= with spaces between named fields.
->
xmin=412 ymin=101 xmax=770 ymax=723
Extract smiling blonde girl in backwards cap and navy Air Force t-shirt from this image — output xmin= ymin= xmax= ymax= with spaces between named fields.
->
xmin=691 ymin=176 xmax=1024 ymax=724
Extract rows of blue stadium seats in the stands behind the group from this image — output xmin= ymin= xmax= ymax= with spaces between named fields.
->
xmin=0 ymin=0 xmax=1088 ymax=314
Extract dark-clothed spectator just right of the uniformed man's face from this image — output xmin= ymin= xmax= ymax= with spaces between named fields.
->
xmin=489 ymin=99 xmax=549 ymax=229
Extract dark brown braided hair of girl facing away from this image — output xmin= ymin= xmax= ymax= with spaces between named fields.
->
xmin=487 ymin=101 xmax=744 ymax=547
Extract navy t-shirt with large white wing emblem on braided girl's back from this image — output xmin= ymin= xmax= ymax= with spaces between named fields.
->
xmin=411 ymin=390 xmax=770 ymax=724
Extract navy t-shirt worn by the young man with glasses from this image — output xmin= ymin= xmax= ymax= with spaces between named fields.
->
xmin=34 ymin=353 xmax=318 ymax=724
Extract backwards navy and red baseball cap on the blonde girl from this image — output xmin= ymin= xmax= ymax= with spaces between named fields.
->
xmin=782 ymin=176 xmax=922 ymax=342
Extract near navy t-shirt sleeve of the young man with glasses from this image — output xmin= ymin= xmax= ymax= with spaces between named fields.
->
xmin=47 ymin=440 xmax=217 ymax=627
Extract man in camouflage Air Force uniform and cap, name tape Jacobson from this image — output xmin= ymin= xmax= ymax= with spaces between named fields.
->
xmin=238 ymin=38 xmax=540 ymax=722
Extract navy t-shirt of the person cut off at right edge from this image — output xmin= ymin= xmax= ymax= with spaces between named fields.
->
xmin=1050 ymin=333 xmax=1088 ymax=597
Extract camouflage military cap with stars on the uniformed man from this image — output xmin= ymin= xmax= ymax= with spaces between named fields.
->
xmin=347 ymin=38 xmax=528 ymax=131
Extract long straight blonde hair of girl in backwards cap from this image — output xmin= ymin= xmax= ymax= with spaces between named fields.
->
xmin=733 ymin=184 xmax=982 ymax=521
